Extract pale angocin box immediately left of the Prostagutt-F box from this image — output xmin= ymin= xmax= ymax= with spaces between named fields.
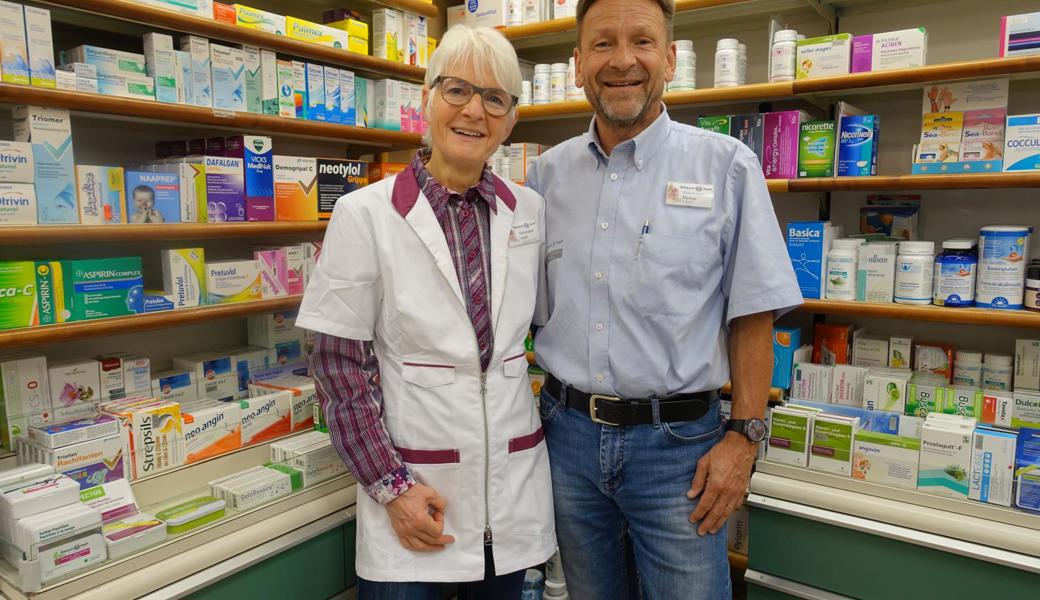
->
xmin=852 ymin=429 xmax=920 ymax=490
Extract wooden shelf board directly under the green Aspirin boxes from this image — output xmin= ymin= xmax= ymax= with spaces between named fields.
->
xmin=0 ymin=295 xmax=303 ymax=349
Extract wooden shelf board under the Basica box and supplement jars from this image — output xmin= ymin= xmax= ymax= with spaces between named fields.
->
xmin=799 ymin=299 xmax=1040 ymax=329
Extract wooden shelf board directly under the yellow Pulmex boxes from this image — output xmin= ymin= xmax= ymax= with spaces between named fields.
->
xmin=42 ymin=0 xmax=426 ymax=81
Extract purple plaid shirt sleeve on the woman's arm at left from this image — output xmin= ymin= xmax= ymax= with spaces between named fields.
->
xmin=311 ymin=333 xmax=416 ymax=504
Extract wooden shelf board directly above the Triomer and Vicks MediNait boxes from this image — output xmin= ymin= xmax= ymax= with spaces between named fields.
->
xmin=0 ymin=83 xmax=422 ymax=150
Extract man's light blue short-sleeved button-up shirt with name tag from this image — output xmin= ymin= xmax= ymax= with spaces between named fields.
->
xmin=527 ymin=109 xmax=802 ymax=398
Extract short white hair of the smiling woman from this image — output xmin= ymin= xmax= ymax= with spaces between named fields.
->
xmin=423 ymin=25 xmax=523 ymax=146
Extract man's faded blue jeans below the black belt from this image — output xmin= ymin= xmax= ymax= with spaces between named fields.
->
xmin=541 ymin=387 xmax=732 ymax=600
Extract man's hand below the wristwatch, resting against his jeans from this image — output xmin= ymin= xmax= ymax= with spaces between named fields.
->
xmin=686 ymin=432 xmax=756 ymax=536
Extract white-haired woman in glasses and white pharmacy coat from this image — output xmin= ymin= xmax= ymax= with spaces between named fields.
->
xmin=296 ymin=25 xmax=555 ymax=600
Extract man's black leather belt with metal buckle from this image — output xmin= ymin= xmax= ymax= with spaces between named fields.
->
xmin=545 ymin=374 xmax=719 ymax=425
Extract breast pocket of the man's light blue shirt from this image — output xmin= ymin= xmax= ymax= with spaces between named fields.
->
xmin=626 ymin=228 xmax=721 ymax=316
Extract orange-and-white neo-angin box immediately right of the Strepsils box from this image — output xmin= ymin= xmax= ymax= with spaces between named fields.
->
xmin=181 ymin=401 xmax=242 ymax=464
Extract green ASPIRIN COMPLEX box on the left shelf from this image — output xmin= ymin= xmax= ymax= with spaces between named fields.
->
xmin=52 ymin=257 xmax=145 ymax=321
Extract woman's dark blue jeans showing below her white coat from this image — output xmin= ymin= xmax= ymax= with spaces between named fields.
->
xmin=358 ymin=546 xmax=524 ymax=600
